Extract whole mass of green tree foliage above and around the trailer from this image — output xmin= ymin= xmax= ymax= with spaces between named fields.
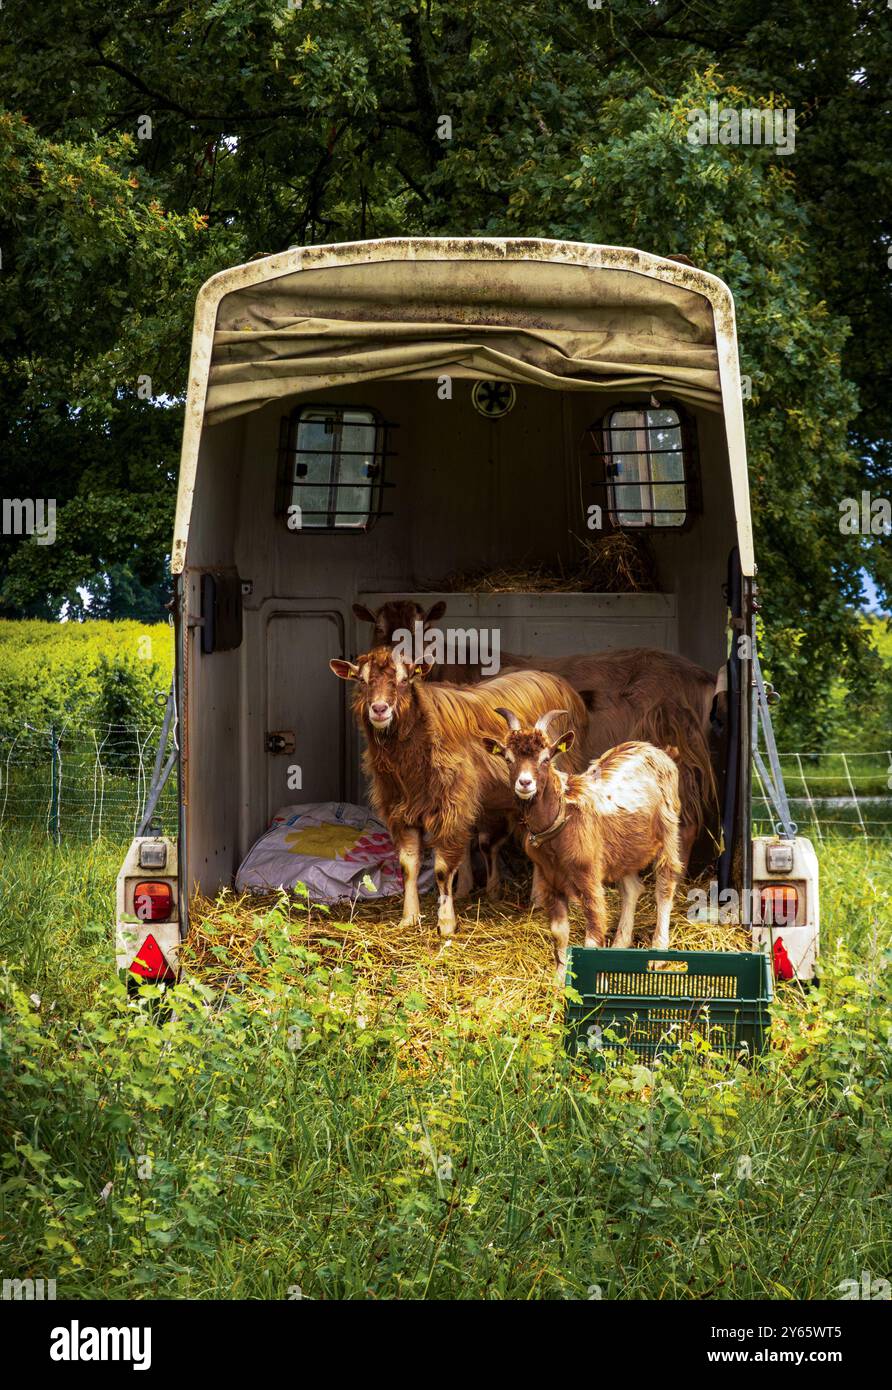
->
xmin=0 ymin=8 xmax=892 ymax=717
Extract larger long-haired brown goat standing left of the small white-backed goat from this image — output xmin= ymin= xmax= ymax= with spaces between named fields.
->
xmin=329 ymin=646 xmax=586 ymax=937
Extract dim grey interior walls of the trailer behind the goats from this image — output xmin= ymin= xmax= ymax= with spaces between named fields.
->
xmin=183 ymin=379 xmax=735 ymax=891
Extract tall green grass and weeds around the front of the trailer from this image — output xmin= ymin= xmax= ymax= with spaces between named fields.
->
xmin=0 ymin=837 xmax=892 ymax=1300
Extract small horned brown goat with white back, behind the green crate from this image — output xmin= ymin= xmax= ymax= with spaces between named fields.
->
xmin=481 ymin=709 xmax=682 ymax=980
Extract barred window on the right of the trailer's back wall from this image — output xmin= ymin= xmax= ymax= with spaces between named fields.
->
xmin=603 ymin=406 xmax=691 ymax=527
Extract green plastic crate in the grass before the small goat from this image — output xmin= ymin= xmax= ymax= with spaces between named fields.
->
xmin=565 ymin=947 xmax=774 ymax=1066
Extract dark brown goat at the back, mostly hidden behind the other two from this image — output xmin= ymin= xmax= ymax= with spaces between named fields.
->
xmin=353 ymin=599 xmax=718 ymax=865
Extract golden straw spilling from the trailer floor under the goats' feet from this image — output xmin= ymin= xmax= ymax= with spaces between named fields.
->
xmin=183 ymin=880 xmax=749 ymax=1045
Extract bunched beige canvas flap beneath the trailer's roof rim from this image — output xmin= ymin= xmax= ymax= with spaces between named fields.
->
xmin=206 ymin=250 xmax=721 ymax=424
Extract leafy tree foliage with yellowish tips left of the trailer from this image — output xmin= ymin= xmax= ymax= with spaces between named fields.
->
xmin=0 ymin=102 xmax=236 ymax=617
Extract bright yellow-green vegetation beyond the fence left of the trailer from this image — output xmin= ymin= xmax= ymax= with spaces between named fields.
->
xmin=0 ymin=620 xmax=174 ymax=731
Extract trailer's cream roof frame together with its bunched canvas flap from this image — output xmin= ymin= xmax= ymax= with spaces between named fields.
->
xmin=172 ymin=238 xmax=753 ymax=573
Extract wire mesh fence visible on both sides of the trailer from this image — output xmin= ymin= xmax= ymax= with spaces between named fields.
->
xmin=0 ymin=724 xmax=892 ymax=842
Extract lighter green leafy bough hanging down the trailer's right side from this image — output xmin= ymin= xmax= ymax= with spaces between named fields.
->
xmin=486 ymin=72 xmax=879 ymax=746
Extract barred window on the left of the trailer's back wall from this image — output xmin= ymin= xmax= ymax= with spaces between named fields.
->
xmin=276 ymin=406 xmax=386 ymax=531
